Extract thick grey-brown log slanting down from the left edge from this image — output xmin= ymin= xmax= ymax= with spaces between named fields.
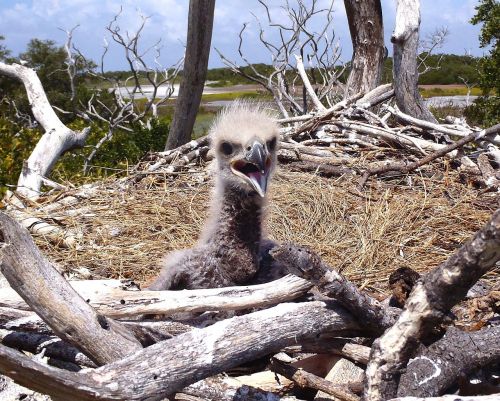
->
xmin=0 ymin=213 xmax=141 ymax=364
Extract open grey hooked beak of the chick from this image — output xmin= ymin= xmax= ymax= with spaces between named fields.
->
xmin=231 ymin=141 xmax=271 ymax=198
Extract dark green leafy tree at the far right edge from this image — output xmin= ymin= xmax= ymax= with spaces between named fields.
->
xmin=465 ymin=0 xmax=500 ymax=127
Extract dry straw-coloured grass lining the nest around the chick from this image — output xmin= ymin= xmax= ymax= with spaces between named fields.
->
xmin=30 ymin=166 xmax=498 ymax=292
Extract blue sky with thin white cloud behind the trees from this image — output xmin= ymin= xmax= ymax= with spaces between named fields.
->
xmin=0 ymin=0 xmax=485 ymax=70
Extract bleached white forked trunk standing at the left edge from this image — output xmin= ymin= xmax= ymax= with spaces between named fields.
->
xmin=0 ymin=63 xmax=90 ymax=198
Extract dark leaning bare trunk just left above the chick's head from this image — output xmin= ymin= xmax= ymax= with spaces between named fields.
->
xmin=165 ymin=0 xmax=215 ymax=150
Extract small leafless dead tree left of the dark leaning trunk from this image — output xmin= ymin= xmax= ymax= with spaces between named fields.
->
xmin=75 ymin=11 xmax=183 ymax=172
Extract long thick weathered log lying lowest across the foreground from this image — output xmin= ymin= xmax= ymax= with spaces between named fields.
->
xmin=0 ymin=302 xmax=358 ymax=401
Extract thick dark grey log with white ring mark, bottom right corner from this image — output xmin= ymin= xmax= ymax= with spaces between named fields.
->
xmin=397 ymin=326 xmax=500 ymax=397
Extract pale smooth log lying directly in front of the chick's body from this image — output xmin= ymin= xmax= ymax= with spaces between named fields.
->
xmin=0 ymin=275 xmax=312 ymax=318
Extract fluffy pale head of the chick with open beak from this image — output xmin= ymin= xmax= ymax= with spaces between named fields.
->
xmin=210 ymin=103 xmax=278 ymax=198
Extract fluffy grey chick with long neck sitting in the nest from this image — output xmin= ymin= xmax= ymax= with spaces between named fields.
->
xmin=148 ymin=102 xmax=279 ymax=290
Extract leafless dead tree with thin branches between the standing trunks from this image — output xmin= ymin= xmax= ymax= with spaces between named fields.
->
xmin=215 ymin=0 xmax=344 ymax=118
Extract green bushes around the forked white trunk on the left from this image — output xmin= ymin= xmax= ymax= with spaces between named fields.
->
xmin=0 ymin=37 xmax=171 ymax=196
